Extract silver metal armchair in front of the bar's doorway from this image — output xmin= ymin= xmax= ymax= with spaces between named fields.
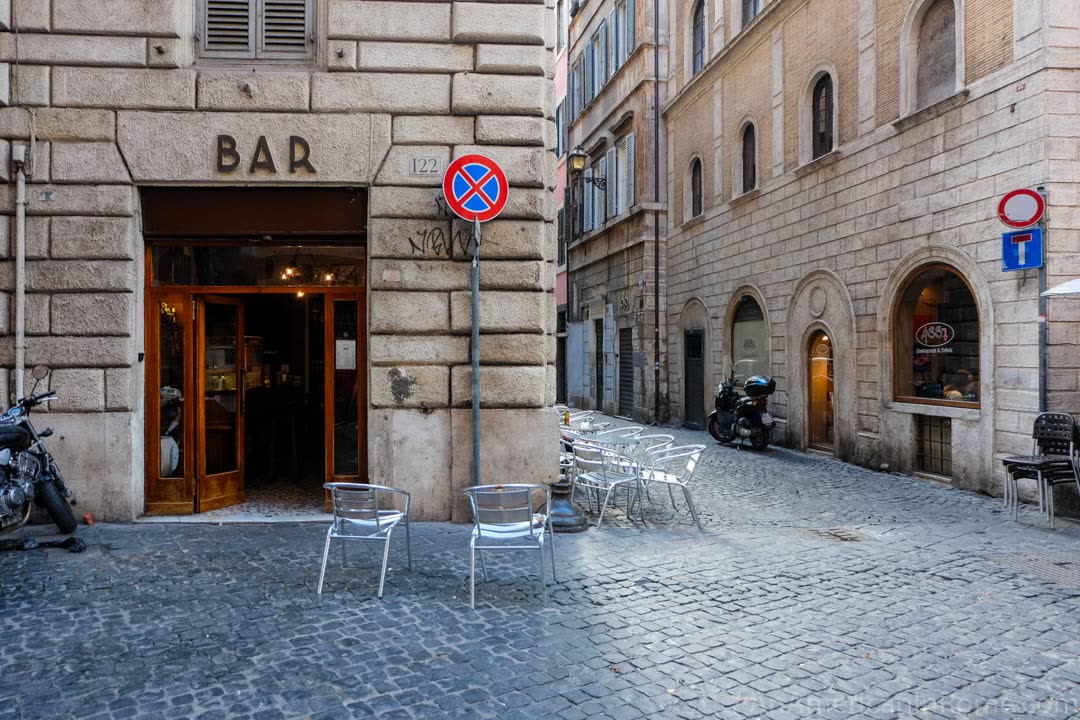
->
xmin=316 ymin=483 xmax=413 ymax=598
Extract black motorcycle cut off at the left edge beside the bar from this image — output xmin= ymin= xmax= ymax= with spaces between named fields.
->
xmin=0 ymin=365 xmax=77 ymax=534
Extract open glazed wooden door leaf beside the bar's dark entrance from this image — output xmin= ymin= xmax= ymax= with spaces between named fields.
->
xmin=195 ymin=295 xmax=244 ymax=513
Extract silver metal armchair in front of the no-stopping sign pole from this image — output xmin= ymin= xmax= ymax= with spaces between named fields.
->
xmin=465 ymin=485 xmax=558 ymax=609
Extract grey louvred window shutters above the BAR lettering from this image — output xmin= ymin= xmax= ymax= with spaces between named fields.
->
xmin=198 ymin=0 xmax=314 ymax=59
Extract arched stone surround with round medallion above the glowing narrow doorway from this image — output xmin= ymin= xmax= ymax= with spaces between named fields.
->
xmin=786 ymin=270 xmax=858 ymax=460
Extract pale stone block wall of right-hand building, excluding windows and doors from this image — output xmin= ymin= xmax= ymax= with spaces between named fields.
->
xmin=667 ymin=0 xmax=1080 ymax=500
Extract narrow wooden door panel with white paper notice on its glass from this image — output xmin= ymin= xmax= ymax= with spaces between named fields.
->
xmin=324 ymin=293 xmax=367 ymax=498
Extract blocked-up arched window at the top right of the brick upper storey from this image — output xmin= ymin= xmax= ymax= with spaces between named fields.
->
xmin=912 ymin=0 xmax=957 ymax=110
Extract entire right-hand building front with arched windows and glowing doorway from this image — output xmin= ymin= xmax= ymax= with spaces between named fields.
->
xmin=666 ymin=0 xmax=1080 ymax=492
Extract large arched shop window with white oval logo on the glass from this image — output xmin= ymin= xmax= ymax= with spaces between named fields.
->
xmin=893 ymin=264 xmax=980 ymax=406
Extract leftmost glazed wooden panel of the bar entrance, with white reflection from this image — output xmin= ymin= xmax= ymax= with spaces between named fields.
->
xmin=146 ymin=294 xmax=198 ymax=515
